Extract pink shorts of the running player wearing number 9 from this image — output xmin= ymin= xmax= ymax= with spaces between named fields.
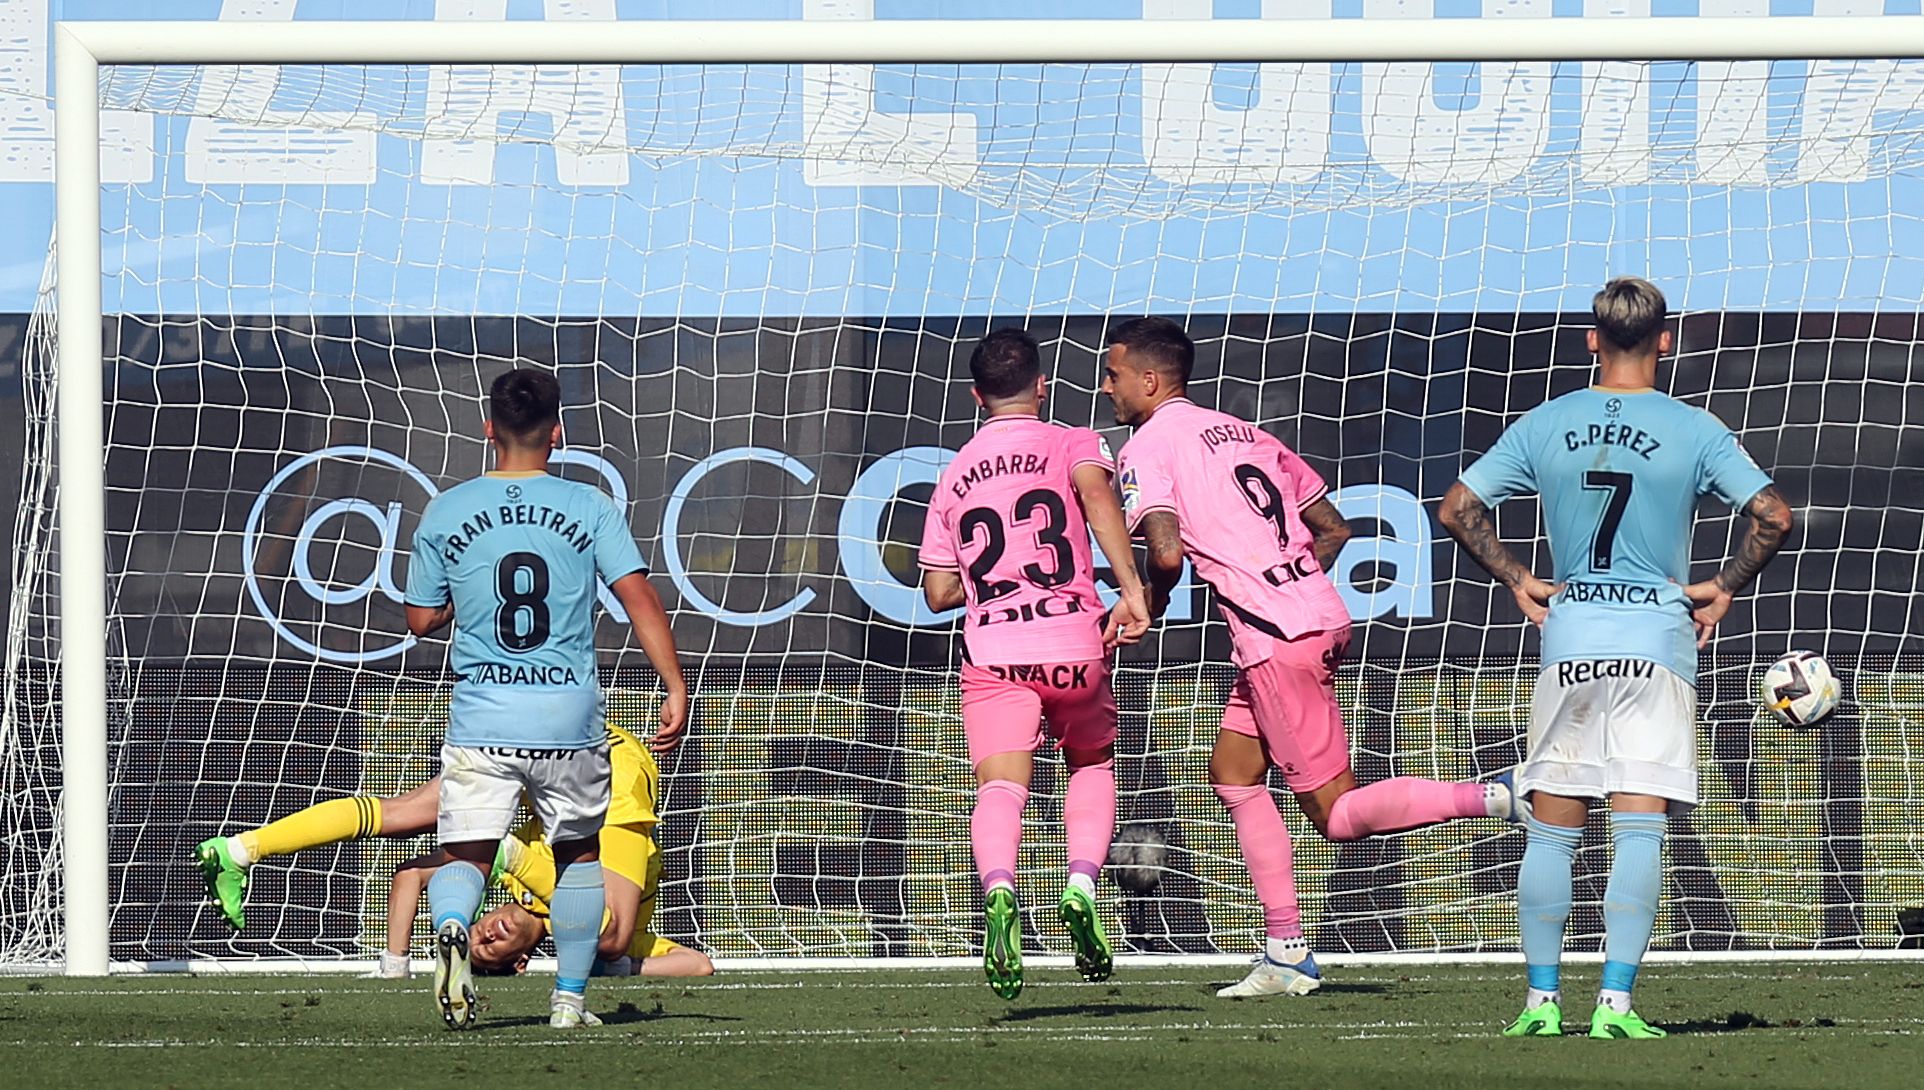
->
xmin=1222 ymin=627 xmax=1349 ymax=794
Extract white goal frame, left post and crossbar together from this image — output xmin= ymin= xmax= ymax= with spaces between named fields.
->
xmin=54 ymin=15 xmax=1924 ymax=975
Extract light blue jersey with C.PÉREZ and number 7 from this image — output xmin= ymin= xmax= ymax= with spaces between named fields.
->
xmin=1462 ymin=386 xmax=1770 ymax=681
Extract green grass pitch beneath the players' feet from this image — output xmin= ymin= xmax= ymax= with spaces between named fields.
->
xmin=0 ymin=961 xmax=1924 ymax=1090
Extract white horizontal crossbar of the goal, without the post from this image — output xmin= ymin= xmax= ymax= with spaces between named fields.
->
xmin=60 ymin=15 xmax=1924 ymax=63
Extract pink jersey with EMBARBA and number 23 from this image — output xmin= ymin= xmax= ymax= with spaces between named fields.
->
xmin=922 ymin=417 xmax=1116 ymax=665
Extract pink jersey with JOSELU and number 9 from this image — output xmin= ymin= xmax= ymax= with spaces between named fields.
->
xmin=1122 ymin=398 xmax=1349 ymax=667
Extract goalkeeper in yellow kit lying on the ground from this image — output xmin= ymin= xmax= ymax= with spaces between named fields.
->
xmin=196 ymin=725 xmax=714 ymax=977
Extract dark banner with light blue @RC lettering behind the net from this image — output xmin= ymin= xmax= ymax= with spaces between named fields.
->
xmin=82 ymin=307 xmax=1900 ymax=671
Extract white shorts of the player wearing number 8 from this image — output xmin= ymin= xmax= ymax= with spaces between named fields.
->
xmin=435 ymin=742 xmax=612 ymax=844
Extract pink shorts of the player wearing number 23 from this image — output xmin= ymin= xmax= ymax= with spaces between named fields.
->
xmin=962 ymin=659 xmax=1116 ymax=765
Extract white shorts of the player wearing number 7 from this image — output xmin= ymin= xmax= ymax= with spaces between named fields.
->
xmin=1516 ymin=659 xmax=1697 ymax=805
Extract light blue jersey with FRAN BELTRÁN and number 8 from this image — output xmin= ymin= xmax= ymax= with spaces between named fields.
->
xmin=408 ymin=473 xmax=646 ymax=750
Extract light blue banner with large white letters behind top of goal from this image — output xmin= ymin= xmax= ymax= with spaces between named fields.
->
xmin=11 ymin=0 xmax=1924 ymax=317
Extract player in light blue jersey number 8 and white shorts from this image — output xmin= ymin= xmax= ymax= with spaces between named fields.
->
xmin=408 ymin=367 xmax=689 ymax=1028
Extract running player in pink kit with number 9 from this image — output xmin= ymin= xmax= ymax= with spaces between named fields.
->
xmin=1102 ymin=317 xmax=1514 ymax=998
